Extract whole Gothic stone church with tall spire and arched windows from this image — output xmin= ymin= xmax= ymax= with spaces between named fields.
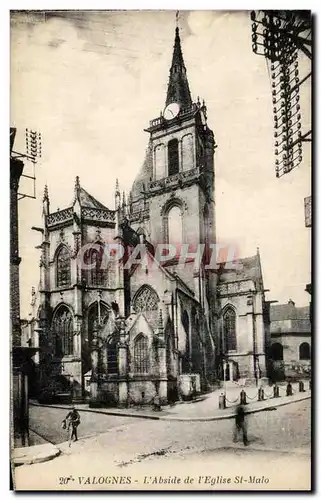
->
xmin=33 ymin=28 xmax=267 ymax=406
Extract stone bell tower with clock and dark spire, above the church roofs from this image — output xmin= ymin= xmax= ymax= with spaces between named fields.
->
xmin=140 ymin=27 xmax=215 ymax=256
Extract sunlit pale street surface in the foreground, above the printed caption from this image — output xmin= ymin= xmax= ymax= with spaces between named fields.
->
xmin=16 ymin=400 xmax=311 ymax=488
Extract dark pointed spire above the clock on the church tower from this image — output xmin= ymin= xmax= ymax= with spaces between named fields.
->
xmin=166 ymin=23 xmax=192 ymax=108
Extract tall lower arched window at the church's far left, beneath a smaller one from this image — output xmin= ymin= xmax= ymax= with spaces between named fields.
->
xmin=51 ymin=305 xmax=74 ymax=358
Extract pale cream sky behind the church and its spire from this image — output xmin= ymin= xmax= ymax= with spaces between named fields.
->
xmin=10 ymin=11 xmax=311 ymax=317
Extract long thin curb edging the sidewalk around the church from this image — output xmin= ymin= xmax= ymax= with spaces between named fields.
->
xmin=30 ymin=391 xmax=311 ymax=422
